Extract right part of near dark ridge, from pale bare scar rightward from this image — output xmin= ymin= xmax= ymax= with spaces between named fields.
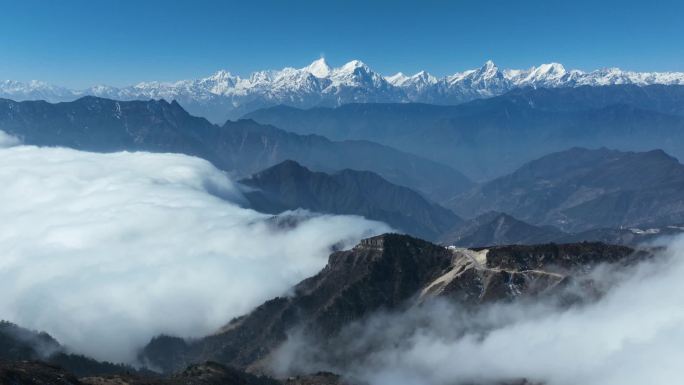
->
xmin=432 ymin=243 xmax=649 ymax=305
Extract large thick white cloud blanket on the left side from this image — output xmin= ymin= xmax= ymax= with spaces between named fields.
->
xmin=0 ymin=143 xmax=388 ymax=361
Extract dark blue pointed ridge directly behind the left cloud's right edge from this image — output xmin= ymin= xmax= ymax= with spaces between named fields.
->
xmin=240 ymin=160 xmax=461 ymax=240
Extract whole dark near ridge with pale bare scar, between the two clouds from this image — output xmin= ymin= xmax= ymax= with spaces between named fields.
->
xmin=141 ymin=234 xmax=647 ymax=372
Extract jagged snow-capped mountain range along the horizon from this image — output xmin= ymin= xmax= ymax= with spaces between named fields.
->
xmin=0 ymin=59 xmax=684 ymax=123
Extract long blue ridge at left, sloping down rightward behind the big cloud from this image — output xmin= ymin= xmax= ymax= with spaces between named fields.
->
xmin=0 ymin=97 xmax=471 ymax=199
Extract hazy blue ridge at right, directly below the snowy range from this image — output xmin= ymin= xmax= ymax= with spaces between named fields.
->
xmin=245 ymin=85 xmax=684 ymax=181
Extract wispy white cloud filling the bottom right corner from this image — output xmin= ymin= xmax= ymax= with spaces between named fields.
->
xmin=274 ymin=238 xmax=684 ymax=385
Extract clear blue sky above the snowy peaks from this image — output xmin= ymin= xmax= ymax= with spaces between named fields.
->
xmin=0 ymin=0 xmax=684 ymax=87
